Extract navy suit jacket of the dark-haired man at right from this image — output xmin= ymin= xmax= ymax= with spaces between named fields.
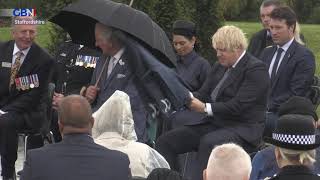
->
xmin=260 ymin=40 xmax=315 ymax=112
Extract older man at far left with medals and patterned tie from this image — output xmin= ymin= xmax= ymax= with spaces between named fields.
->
xmin=0 ymin=17 xmax=54 ymax=180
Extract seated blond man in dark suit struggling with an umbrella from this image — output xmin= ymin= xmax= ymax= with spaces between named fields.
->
xmin=156 ymin=26 xmax=269 ymax=179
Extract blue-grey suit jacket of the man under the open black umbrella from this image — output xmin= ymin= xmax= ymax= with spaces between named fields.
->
xmin=91 ymin=51 xmax=147 ymax=142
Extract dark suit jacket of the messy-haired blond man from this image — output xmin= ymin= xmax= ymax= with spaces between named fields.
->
xmin=194 ymin=53 xmax=269 ymax=145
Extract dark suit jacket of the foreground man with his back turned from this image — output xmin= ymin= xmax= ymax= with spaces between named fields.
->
xmin=21 ymin=134 xmax=131 ymax=180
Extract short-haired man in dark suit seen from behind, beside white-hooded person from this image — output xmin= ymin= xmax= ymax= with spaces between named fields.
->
xmin=21 ymin=95 xmax=131 ymax=180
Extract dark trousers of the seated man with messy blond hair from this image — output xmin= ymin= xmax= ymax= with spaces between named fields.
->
xmin=156 ymin=122 xmax=244 ymax=179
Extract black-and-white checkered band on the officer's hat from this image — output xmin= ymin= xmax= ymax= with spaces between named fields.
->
xmin=272 ymin=133 xmax=316 ymax=145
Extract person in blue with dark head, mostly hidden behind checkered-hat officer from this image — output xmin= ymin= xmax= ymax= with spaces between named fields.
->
xmin=250 ymin=96 xmax=320 ymax=180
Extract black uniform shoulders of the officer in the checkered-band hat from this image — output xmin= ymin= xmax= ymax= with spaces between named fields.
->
xmin=270 ymin=166 xmax=320 ymax=180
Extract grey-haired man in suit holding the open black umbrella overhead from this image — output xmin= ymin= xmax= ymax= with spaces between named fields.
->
xmin=85 ymin=23 xmax=147 ymax=142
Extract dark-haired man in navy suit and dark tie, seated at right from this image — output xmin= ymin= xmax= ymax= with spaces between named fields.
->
xmin=261 ymin=6 xmax=315 ymax=137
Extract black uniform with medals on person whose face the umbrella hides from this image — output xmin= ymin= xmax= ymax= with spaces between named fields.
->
xmin=54 ymin=41 xmax=101 ymax=95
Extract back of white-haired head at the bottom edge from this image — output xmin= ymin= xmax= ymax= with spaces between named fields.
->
xmin=203 ymin=143 xmax=251 ymax=180
